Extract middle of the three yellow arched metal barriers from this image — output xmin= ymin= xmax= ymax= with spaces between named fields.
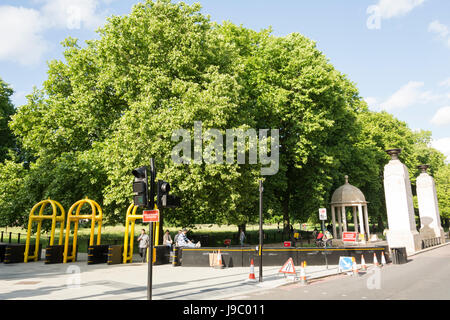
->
xmin=63 ymin=198 xmax=103 ymax=263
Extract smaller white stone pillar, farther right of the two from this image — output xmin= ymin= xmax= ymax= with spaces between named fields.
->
xmin=416 ymin=164 xmax=445 ymax=243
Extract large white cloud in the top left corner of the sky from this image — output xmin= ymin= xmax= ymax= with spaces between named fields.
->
xmin=0 ymin=6 xmax=48 ymax=65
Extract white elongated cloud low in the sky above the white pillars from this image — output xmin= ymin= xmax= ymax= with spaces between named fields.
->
xmin=380 ymin=81 xmax=440 ymax=110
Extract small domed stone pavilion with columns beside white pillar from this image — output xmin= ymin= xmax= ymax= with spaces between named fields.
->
xmin=330 ymin=176 xmax=370 ymax=239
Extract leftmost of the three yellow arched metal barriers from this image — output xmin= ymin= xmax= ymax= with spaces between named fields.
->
xmin=24 ymin=199 xmax=65 ymax=262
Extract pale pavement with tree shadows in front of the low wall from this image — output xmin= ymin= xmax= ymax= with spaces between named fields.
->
xmin=0 ymin=243 xmax=450 ymax=300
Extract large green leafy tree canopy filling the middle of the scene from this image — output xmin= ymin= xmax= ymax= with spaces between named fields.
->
xmin=0 ymin=0 xmax=449 ymax=231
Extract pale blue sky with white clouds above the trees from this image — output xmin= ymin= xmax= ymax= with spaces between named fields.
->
xmin=0 ymin=0 xmax=450 ymax=159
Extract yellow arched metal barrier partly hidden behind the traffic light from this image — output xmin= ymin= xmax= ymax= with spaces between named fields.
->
xmin=123 ymin=204 xmax=159 ymax=263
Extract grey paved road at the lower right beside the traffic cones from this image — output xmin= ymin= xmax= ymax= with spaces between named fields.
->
xmin=230 ymin=246 xmax=450 ymax=300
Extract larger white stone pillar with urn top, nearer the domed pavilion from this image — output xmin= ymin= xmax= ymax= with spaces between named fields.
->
xmin=384 ymin=149 xmax=421 ymax=254
